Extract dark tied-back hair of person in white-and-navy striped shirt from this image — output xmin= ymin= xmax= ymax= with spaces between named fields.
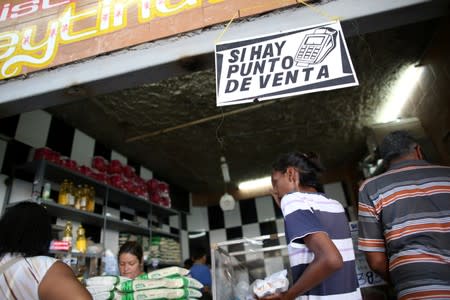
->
xmin=272 ymin=152 xmax=324 ymax=193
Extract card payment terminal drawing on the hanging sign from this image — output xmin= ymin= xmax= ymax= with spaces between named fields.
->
xmin=295 ymin=27 xmax=337 ymax=67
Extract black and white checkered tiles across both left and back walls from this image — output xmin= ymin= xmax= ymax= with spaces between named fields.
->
xmin=0 ymin=110 xmax=356 ymax=259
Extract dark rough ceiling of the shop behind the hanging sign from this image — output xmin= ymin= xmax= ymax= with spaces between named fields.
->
xmin=42 ymin=16 xmax=437 ymax=200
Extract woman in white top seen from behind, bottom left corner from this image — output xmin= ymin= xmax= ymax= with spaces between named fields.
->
xmin=0 ymin=201 xmax=92 ymax=300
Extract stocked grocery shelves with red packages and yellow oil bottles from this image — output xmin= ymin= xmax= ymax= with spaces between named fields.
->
xmin=5 ymin=148 xmax=181 ymax=276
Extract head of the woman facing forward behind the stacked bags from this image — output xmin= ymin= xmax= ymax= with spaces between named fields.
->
xmin=118 ymin=241 xmax=144 ymax=279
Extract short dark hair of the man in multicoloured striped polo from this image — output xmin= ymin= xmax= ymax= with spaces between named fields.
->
xmin=380 ymin=130 xmax=417 ymax=162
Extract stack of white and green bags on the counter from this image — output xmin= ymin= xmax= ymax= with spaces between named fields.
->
xmin=86 ymin=267 xmax=203 ymax=300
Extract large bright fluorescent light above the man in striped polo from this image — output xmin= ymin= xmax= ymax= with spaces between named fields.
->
xmin=377 ymin=65 xmax=423 ymax=123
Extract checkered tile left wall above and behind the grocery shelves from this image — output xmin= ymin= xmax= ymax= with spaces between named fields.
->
xmin=0 ymin=110 xmax=189 ymax=257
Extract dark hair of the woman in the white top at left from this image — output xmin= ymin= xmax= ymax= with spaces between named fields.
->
xmin=0 ymin=201 xmax=52 ymax=257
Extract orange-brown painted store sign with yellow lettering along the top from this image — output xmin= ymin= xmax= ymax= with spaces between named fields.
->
xmin=0 ymin=0 xmax=306 ymax=80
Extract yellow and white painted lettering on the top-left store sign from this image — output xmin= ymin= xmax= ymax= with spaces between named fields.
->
xmin=0 ymin=0 xmax=225 ymax=79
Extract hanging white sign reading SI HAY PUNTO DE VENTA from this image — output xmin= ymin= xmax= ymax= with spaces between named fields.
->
xmin=215 ymin=22 xmax=358 ymax=106
